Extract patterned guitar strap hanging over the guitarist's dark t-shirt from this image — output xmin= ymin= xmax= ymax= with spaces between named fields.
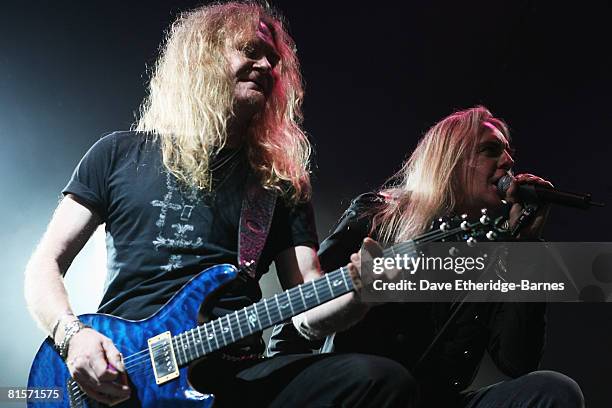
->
xmin=238 ymin=172 xmax=277 ymax=279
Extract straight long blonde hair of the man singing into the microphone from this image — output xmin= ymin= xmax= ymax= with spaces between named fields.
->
xmin=373 ymin=106 xmax=509 ymax=243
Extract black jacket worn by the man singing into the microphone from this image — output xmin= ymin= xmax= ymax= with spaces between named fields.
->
xmin=268 ymin=193 xmax=545 ymax=402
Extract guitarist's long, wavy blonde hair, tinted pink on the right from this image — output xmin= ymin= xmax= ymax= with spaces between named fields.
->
xmin=134 ymin=2 xmax=311 ymax=202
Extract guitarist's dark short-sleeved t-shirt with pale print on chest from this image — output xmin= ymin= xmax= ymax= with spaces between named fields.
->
xmin=63 ymin=132 xmax=318 ymax=354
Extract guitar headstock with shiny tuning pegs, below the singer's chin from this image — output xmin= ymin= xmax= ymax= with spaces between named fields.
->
xmin=425 ymin=208 xmax=510 ymax=246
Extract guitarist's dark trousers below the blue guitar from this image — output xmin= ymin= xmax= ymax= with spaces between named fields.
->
xmin=190 ymin=354 xmax=416 ymax=408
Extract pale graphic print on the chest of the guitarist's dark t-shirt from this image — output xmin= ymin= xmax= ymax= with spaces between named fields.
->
xmin=151 ymin=172 xmax=203 ymax=272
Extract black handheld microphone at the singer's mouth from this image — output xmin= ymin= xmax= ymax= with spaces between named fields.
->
xmin=497 ymin=174 xmax=604 ymax=210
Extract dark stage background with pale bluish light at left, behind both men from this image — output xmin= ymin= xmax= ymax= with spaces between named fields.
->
xmin=0 ymin=1 xmax=612 ymax=407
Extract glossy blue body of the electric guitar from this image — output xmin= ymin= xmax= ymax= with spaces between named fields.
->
xmin=28 ymin=265 xmax=238 ymax=408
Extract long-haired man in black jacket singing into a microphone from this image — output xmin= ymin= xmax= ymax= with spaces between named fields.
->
xmin=270 ymin=106 xmax=584 ymax=408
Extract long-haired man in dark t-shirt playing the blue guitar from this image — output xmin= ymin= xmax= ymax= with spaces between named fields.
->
xmin=25 ymin=2 xmax=409 ymax=407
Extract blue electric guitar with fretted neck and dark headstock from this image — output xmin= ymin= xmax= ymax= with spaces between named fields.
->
xmin=28 ymin=215 xmax=501 ymax=408
